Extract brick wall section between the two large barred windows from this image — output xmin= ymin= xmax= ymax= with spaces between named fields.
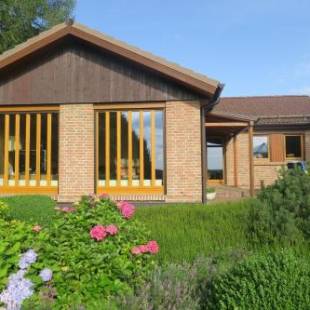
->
xmin=58 ymin=104 xmax=95 ymax=202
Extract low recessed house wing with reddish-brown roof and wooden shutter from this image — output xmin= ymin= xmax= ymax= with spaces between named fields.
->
xmin=205 ymin=96 xmax=310 ymax=194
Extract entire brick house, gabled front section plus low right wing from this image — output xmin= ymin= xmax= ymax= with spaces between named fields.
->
xmin=0 ymin=24 xmax=310 ymax=202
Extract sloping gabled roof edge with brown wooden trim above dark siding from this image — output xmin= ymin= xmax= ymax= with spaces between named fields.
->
xmin=0 ymin=23 xmax=221 ymax=96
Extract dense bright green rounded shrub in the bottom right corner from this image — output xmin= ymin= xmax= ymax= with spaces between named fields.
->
xmin=207 ymin=250 xmax=310 ymax=309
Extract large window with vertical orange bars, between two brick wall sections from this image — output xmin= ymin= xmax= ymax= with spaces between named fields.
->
xmin=97 ymin=110 xmax=164 ymax=192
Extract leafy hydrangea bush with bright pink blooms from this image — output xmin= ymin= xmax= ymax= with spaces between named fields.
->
xmin=17 ymin=195 xmax=159 ymax=309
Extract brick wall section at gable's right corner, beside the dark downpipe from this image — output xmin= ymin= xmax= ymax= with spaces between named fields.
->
xmin=166 ymin=101 xmax=202 ymax=202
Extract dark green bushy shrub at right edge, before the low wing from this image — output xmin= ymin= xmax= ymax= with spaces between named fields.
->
xmin=248 ymin=168 xmax=310 ymax=243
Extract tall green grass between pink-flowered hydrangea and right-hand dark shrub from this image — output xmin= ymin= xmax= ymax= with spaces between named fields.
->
xmin=137 ymin=200 xmax=251 ymax=262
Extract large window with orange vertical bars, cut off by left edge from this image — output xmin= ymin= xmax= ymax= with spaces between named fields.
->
xmin=0 ymin=112 xmax=58 ymax=190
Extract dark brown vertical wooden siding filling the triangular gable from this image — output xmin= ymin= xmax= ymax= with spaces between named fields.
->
xmin=0 ymin=38 xmax=198 ymax=105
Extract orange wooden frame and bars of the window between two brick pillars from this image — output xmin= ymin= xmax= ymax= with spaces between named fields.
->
xmin=94 ymin=103 xmax=166 ymax=195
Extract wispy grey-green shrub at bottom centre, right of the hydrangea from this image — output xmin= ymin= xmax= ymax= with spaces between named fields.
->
xmin=118 ymin=258 xmax=215 ymax=310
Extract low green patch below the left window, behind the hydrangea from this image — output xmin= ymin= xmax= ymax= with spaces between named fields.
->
xmin=0 ymin=195 xmax=56 ymax=225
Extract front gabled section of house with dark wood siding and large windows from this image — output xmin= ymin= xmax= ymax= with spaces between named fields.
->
xmin=0 ymin=24 xmax=222 ymax=202
